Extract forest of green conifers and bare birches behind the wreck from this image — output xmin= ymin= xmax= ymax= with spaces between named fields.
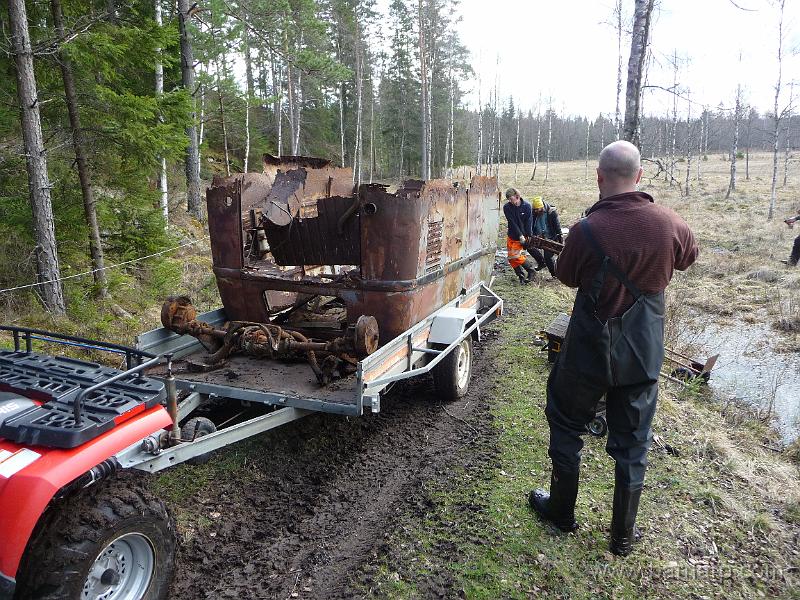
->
xmin=0 ymin=0 xmax=800 ymax=333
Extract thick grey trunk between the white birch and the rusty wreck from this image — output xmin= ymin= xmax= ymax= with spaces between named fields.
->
xmin=178 ymin=0 xmax=203 ymax=220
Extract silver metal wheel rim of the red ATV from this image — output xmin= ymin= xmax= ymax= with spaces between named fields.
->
xmin=81 ymin=533 xmax=155 ymax=600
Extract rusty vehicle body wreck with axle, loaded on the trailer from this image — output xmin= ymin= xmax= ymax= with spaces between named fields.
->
xmin=162 ymin=155 xmax=500 ymax=383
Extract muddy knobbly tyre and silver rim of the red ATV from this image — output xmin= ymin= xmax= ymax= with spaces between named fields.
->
xmin=17 ymin=477 xmax=176 ymax=600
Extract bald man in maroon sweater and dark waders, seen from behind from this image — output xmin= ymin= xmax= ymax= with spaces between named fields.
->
xmin=528 ymin=141 xmax=698 ymax=556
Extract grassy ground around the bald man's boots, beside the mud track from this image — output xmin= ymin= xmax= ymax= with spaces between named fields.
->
xmin=376 ymin=271 xmax=798 ymax=600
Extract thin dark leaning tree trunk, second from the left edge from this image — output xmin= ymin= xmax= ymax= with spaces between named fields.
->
xmin=50 ymin=0 xmax=108 ymax=298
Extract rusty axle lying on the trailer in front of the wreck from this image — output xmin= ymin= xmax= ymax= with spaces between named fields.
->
xmin=161 ymin=296 xmax=379 ymax=385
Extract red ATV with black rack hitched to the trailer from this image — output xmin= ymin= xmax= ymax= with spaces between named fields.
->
xmin=0 ymin=327 xmax=176 ymax=600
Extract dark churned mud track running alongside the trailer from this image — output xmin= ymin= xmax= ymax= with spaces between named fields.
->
xmin=171 ymin=331 xmax=496 ymax=599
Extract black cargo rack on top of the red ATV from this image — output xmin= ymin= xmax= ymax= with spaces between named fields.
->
xmin=0 ymin=326 xmax=166 ymax=448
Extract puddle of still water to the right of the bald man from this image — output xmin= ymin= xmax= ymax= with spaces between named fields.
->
xmin=685 ymin=322 xmax=800 ymax=443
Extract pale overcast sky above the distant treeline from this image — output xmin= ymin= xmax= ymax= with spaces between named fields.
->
xmin=438 ymin=0 xmax=800 ymax=116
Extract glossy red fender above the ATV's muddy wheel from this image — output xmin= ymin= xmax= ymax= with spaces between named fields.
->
xmin=0 ymin=405 xmax=172 ymax=588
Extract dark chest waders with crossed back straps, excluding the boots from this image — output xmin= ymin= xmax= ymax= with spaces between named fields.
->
xmin=545 ymin=219 xmax=664 ymax=487
